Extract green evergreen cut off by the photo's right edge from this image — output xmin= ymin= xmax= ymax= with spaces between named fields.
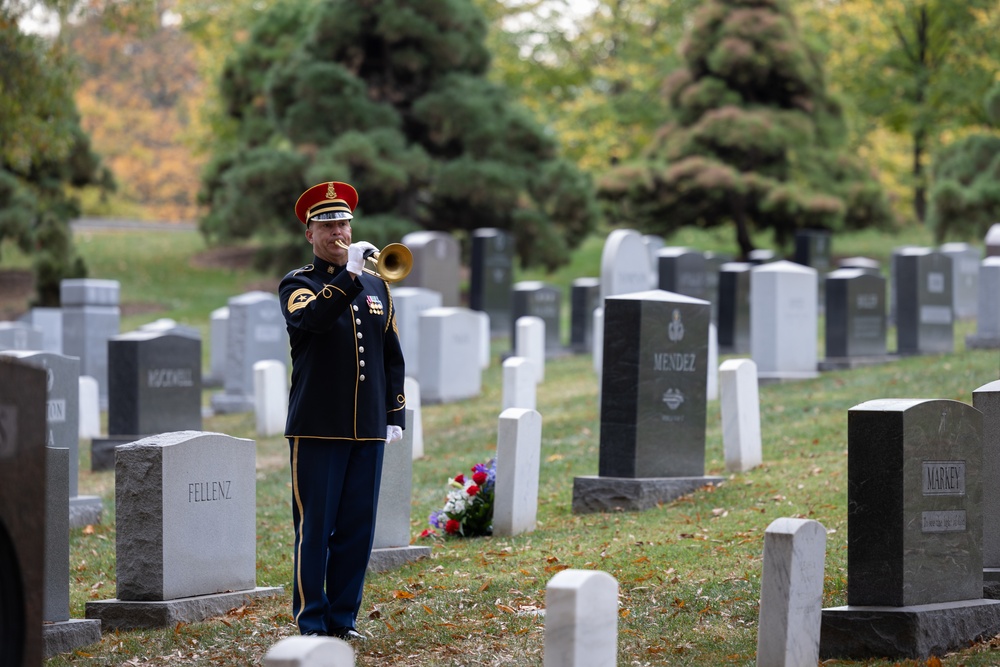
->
xmin=927 ymin=84 xmax=1000 ymax=243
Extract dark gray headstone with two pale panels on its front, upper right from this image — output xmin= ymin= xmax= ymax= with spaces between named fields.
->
xmin=896 ymin=248 xmax=955 ymax=354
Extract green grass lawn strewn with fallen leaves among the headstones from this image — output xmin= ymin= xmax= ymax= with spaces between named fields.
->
xmin=39 ymin=223 xmax=1000 ymax=667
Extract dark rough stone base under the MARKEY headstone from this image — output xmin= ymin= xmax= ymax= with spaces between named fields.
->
xmin=819 ymin=600 xmax=1000 ymax=660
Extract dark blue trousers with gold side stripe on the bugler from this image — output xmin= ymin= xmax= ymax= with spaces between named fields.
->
xmin=288 ymin=438 xmax=385 ymax=634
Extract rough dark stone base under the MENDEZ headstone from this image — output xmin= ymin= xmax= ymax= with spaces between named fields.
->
xmin=573 ymin=475 xmax=725 ymax=514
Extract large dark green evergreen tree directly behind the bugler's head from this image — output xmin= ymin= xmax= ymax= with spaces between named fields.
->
xmin=201 ymin=0 xmax=598 ymax=268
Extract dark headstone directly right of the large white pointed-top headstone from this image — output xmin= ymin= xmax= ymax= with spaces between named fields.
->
xmin=826 ymin=269 xmax=887 ymax=358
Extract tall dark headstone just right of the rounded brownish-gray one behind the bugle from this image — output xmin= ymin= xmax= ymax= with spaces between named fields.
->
xmin=470 ymin=228 xmax=514 ymax=336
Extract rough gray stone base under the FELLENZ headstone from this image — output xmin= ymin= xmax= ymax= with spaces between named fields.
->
xmin=85 ymin=586 xmax=284 ymax=632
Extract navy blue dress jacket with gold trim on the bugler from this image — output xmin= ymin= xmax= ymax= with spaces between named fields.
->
xmin=278 ymin=257 xmax=406 ymax=440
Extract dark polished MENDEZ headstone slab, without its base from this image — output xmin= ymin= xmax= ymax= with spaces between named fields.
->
xmin=599 ymin=290 xmax=710 ymax=478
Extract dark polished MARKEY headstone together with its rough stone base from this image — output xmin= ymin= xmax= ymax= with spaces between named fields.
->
xmin=820 ymin=398 xmax=1000 ymax=660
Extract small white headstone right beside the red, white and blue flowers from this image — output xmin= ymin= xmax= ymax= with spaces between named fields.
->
xmin=493 ymin=408 xmax=542 ymax=536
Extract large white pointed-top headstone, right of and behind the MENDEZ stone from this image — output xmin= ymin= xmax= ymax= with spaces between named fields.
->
xmin=750 ymin=260 xmax=819 ymax=379
